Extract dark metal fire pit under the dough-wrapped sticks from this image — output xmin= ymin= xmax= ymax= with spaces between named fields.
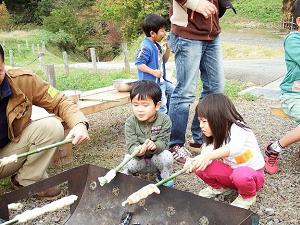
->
xmin=0 ymin=165 xmax=259 ymax=225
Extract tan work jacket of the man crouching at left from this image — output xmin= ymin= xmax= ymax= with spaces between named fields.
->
xmin=6 ymin=69 xmax=87 ymax=142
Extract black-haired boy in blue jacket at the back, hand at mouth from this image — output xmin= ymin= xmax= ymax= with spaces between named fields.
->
xmin=135 ymin=14 xmax=174 ymax=113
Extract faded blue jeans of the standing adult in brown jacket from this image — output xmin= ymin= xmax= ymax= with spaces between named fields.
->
xmin=169 ymin=33 xmax=224 ymax=146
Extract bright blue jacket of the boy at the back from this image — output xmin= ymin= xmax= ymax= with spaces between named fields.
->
xmin=135 ymin=37 xmax=166 ymax=82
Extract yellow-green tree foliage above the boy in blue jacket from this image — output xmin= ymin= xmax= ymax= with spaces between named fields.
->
xmin=98 ymin=0 xmax=169 ymax=42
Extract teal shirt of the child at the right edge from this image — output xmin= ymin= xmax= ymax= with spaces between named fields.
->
xmin=280 ymin=31 xmax=300 ymax=94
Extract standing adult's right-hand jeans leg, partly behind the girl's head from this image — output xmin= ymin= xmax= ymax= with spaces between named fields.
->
xmin=191 ymin=37 xmax=224 ymax=144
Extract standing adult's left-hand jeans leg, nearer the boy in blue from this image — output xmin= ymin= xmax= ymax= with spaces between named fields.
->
xmin=169 ymin=34 xmax=202 ymax=147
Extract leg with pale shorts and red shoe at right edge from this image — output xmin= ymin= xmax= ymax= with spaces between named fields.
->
xmin=265 ymin=94 xmax=300 ymax=174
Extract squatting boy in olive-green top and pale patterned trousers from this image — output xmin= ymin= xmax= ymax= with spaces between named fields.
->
xmin=123 ymin=80 xmax=174 ymax=187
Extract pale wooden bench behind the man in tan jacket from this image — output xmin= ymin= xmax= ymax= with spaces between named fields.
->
xmin=33 ymin=86 xmax=129 ymax=165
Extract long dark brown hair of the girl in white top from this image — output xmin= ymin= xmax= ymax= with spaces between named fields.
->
xmin=196 ymin=94 xmax=249 ymax=149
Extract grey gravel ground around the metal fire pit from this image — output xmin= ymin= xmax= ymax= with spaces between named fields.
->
xmin=3 ymin=99 xmax=300 ymax=225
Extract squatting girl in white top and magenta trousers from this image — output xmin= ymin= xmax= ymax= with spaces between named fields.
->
xmin=185 ymin=94 xmax=265 ymax=209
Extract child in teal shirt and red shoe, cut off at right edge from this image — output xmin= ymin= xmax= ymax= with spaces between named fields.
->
xmin=265 ymin=0 xmax=300 ymax=174
